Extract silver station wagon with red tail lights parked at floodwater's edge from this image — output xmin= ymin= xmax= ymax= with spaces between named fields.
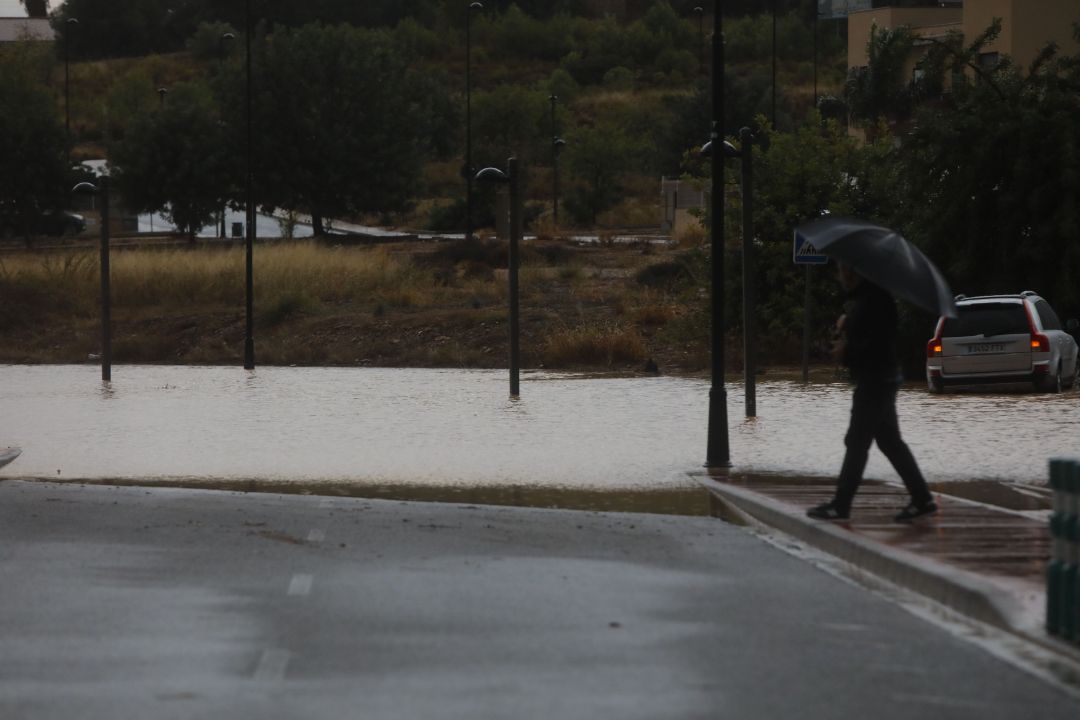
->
xmin=927 ymin=290 xmax=1080 ymax=393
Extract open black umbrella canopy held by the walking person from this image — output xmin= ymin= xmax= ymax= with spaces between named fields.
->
xmin=795 ymin=218 xmax=957 ymax=317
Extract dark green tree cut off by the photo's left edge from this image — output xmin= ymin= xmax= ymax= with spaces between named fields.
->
xmin=0 ymin=42 xmax=70 ymax=239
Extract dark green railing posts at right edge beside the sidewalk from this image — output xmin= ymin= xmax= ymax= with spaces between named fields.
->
xmin=1047 ymin=458 xmax=1080 ymax=644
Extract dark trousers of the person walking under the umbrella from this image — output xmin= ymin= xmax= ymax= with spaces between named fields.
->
xmin=834 ymin=382 xmax=933 ymax=511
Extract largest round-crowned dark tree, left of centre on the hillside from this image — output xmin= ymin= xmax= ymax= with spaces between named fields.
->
xmin=234 ymin=25 xmax=454 ymax=234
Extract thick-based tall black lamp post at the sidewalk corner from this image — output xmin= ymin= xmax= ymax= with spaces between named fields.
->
xmin=705 ymin=0 xmax=731 ymax=467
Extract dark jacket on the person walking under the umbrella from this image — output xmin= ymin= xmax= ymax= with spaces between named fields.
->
xmin=841 ymin=281 xmax=904 ymax=384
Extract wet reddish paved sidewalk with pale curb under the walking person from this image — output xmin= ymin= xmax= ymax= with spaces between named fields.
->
xmin=702 ymin=472 xmax=1080 ymax=658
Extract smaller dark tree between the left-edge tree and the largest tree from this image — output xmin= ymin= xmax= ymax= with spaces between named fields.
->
xmin=110 ymin=83 xmax=235 ymax=240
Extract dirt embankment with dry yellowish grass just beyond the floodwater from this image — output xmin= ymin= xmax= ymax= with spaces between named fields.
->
xmin=0 ymin=235 xmax=816 ymax=375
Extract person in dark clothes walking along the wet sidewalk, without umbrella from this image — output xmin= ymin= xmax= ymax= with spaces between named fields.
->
xmin=807 ymin=263 xmax=937 ymax=522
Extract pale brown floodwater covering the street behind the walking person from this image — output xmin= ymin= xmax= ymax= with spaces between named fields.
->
xmin=0 ymin=365 xmax=1080 ymax=493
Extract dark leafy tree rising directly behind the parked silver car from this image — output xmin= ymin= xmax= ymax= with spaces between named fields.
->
xmin=902 ymin=26 xmax=1080 ymax=316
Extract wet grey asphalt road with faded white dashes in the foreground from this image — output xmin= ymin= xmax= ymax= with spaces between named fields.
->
xmin=0 ymin=480 xmax=1080 ymax=720
